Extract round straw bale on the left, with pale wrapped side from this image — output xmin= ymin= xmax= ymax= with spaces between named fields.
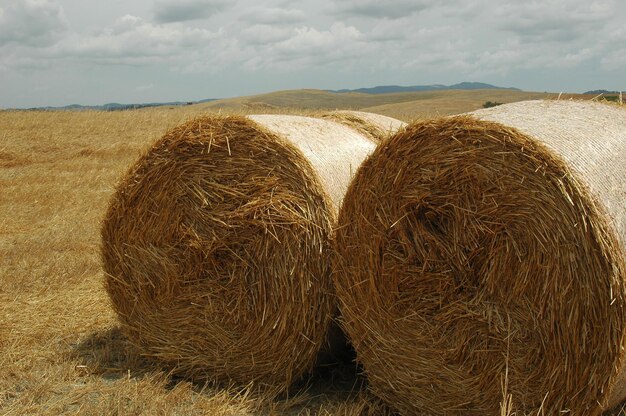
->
xmin=102 ymin=115 xmax=374 ymax=393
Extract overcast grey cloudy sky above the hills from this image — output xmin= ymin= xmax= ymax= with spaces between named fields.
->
xmin=0 ymin=0 xmax=626 ymax=108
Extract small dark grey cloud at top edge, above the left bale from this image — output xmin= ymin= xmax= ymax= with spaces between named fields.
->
xmin=154 ymin=0 xmax=233 ymax=23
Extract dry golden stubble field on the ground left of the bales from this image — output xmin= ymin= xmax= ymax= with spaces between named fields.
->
xmin=0 ymin=93 xmax=620 ymax=416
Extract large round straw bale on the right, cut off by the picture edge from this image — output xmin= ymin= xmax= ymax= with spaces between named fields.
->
xmin=334 ymin=101 xmax=626 ymax=415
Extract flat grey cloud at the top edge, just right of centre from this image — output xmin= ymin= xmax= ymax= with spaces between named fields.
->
xmin=334 ymin=0 xmax=436 ymax=19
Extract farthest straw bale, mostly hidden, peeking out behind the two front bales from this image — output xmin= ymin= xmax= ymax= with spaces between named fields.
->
xmin=321 ymin=110 xmax=406 ymax=143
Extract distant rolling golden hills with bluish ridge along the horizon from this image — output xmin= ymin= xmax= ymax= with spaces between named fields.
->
xmin=8 ymin=84 xmax=596 ymax=121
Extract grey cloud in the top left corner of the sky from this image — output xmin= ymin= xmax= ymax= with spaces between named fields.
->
xmin=0 ymin=0 xmax=68 ymax=47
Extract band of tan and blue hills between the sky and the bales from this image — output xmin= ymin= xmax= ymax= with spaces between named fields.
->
xmin=13 ymin=82 xmax=600 ymax=114
